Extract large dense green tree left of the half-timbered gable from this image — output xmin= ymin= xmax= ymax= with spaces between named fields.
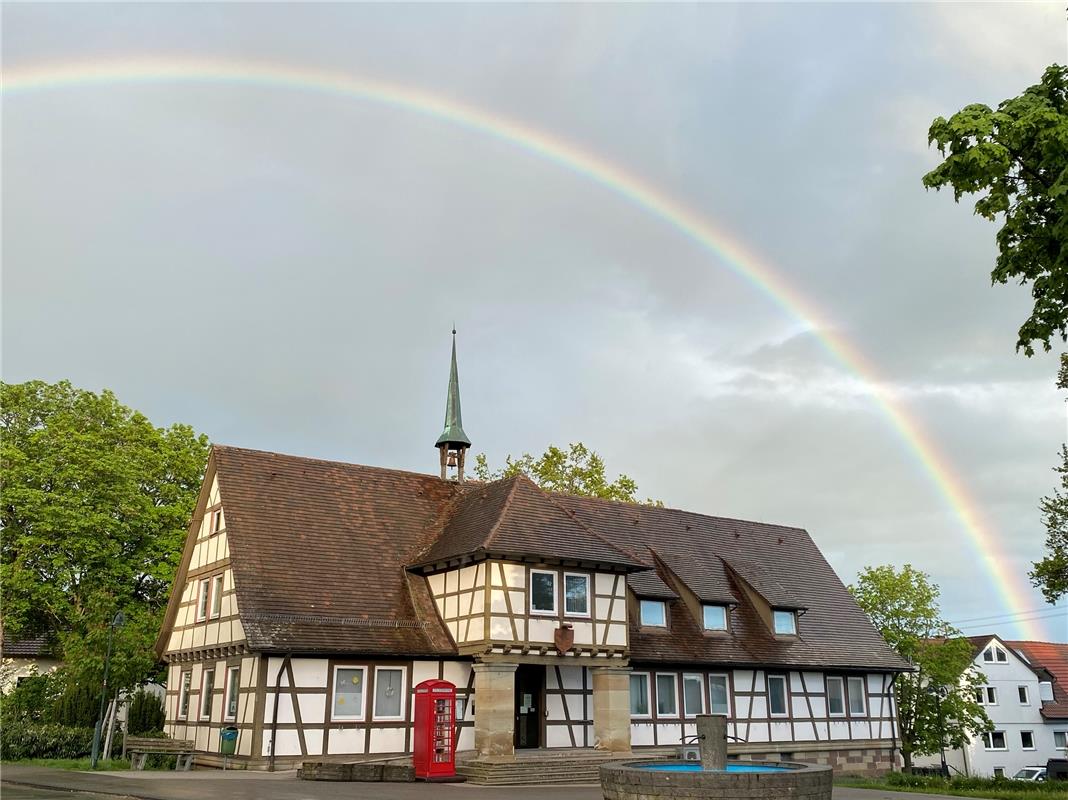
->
xmin=0 ymin=380 xmax=208 ymax=689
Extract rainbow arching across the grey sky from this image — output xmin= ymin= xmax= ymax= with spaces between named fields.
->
xmin=2 ymin=57 xmax=1043 ymax=640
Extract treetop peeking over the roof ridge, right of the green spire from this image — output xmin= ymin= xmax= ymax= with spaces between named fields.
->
xmin=474 ymin=442 xmax=663 ymax=505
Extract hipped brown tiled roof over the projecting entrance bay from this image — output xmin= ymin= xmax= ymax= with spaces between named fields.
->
xmin=415 ymin=475 xmax=648 ymax=569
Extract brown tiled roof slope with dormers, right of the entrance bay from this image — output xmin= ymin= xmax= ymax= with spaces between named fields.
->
xmin=557 ymin=497 xmax=910 ymax=670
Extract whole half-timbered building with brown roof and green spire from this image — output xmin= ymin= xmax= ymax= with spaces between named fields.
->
xmin=157 ymin=335 xmax=908 ymax=771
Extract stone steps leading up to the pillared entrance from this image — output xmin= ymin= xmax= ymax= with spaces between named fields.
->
xmin=456 ymin=749 xmax=674 ymax=786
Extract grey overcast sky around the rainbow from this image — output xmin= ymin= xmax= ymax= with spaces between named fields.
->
xmin=2 ymin=3 xmax=1068 ymax=641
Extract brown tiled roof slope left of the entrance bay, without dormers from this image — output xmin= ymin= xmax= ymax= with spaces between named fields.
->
xmin=214 ymin=446 xmax=455 ymax=655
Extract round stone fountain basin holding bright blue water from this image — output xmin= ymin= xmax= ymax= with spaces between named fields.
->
xmin=600 ymin=759 xmax=833 ymax=800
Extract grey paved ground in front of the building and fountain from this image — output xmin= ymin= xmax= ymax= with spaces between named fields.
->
xmin=0 ymin=765 xmax=978 ymax=800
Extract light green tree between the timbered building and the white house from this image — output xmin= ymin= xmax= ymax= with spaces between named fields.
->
xmin=849 ymin=564 xmax=993 ymax=771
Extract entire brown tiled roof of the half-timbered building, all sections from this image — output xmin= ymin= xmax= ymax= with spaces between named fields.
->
xmin=170 ymin=446 xmax=908 ymax=670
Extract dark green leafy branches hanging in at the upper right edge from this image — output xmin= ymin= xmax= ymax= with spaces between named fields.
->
xmin=924 ymin=64 xmax=1068 ymax=356
